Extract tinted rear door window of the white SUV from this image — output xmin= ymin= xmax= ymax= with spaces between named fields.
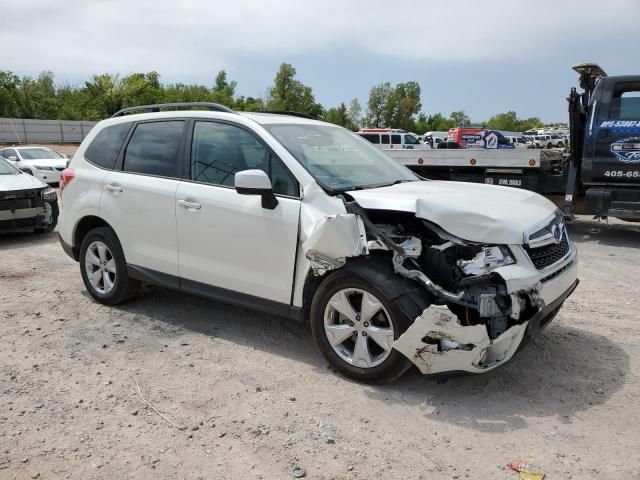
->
xmin=122 ymin=121 xmax=184 ymax=177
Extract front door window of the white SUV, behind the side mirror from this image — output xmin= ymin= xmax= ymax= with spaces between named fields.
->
xmin=191 ymin=122 xmax=299 ymax=197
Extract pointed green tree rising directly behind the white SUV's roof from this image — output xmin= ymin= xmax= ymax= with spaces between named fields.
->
xmin=267 ymin=63 xmax=323 ymax=118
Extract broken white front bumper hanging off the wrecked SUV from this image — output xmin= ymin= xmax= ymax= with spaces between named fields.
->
xmin=393 ymin=277 xmax=579 ymax=374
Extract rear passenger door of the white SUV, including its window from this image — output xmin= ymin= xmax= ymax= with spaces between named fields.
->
xmin=100 ymin=119 xmax=187 ymax=281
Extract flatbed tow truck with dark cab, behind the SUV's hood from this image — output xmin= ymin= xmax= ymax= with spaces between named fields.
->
xmin=385 ymin=63 xmax=640 ymax=221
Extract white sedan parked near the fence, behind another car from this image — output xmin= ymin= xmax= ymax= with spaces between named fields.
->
xmin=0 ymin=147 xmax=69 ymax=184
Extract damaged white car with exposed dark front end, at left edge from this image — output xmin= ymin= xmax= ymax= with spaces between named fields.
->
xmin=0 ymin=158 xmax=58 ymax=233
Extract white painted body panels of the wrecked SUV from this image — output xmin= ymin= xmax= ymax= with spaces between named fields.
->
xmin=59 ymin=111 xmax=577 ymax=378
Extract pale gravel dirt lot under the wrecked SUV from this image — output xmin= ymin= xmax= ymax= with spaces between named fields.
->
xmin=0 ymin=219 xmax=640 ymax=480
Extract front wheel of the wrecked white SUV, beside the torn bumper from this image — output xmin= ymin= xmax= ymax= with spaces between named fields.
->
xmin=311 ymin=260 xmax=429 ymax=383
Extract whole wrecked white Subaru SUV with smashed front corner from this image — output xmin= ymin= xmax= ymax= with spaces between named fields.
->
xmin=59 ymin=104 xmax=578 ymax=382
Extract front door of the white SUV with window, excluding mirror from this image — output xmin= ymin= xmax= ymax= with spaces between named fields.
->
xmin=176 ymin=120 xmax=300 ymax=304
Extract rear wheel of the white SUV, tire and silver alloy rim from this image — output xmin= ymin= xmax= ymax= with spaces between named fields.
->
xmin=79 ymin=227 xmax=140 ymax=305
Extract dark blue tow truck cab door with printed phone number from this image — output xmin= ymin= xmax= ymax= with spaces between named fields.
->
xmin=582 ymin=78 xmax=640 ymax=184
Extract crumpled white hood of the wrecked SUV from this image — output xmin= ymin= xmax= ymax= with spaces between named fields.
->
xmin=348 ymin=180 xmax=556 ymax=244
